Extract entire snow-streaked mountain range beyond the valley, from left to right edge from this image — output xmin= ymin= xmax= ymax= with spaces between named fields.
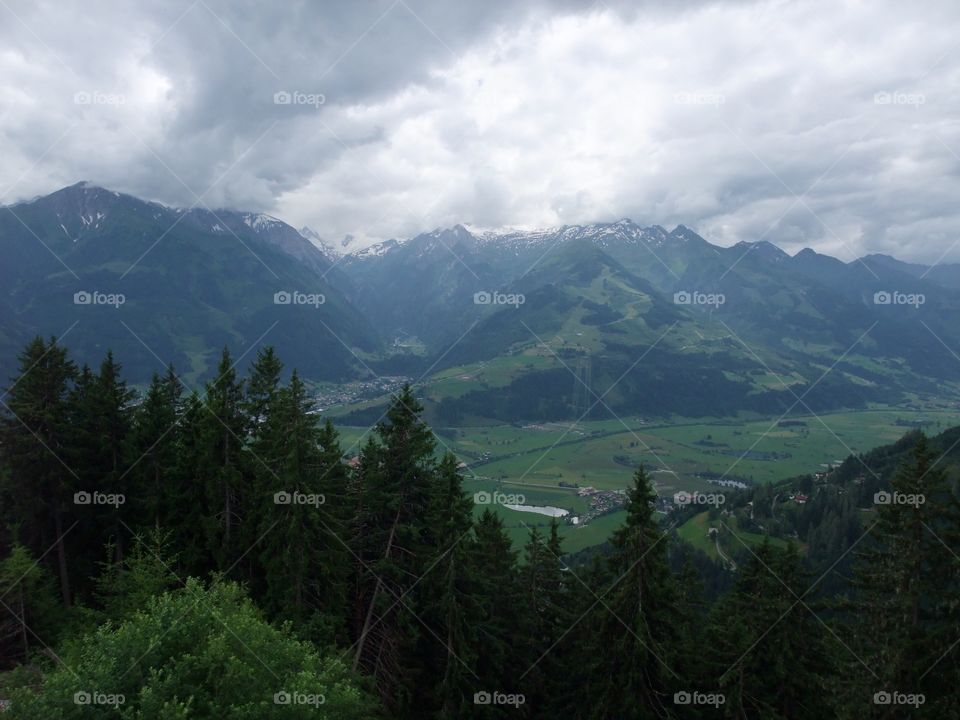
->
xmin=0 ymin=183 xmax=960 ymax=423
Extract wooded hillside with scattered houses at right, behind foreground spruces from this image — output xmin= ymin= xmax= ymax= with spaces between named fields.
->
xmin=648 ymin=427 xmax=960 ymax=598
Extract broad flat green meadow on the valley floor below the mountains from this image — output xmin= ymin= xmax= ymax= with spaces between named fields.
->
xmin=443 ymin=408 xmax=960 ymax=492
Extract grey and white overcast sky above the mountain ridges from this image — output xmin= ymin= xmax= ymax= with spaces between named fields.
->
xmin=0 ymin=0 xmax=960 ymax=262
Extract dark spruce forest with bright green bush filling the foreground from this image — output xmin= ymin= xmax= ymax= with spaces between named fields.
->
xmin=0 ymin=338 xmax=960 ymax=720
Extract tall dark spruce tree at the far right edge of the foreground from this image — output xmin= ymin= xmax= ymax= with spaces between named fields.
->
xmin=849 ymin=435 xmax=960 ymax=717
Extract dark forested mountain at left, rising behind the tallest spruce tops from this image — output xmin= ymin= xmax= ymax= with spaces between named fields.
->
xmin=0 ymin=183 xmax=377 ymax=381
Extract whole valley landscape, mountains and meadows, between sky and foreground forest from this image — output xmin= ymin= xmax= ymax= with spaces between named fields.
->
xmin=11 ymin=183 xmax=960 ymax=551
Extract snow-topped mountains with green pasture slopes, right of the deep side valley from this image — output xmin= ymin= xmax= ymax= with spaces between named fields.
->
xmin=341 ymin=219 xmax=960 ymax=419
